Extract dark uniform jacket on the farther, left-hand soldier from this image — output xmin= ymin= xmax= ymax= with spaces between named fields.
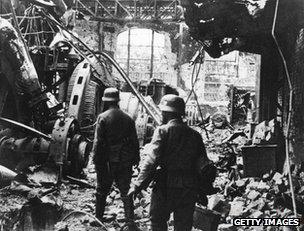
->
xmin=93 ymin=107 xmax=139 ymax=164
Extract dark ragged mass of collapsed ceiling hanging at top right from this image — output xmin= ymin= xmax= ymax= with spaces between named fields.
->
xmin=181 ymin=0 xmax=304 ymax=58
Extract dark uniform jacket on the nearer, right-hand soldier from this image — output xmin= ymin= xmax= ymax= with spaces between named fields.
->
xmin=137 ymin=119 xmax=208 ymax=188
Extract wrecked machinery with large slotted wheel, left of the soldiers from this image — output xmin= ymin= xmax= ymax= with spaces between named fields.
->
xmin=0 ymin=14 xmax=107 ymax=177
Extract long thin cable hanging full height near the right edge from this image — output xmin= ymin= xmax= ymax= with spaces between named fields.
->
xmin=271 ymin=0 xmax=297 ymax=217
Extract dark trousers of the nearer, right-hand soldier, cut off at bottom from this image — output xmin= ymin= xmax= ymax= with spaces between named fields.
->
xmin=150 ymin=187 xmax=197 ymax=231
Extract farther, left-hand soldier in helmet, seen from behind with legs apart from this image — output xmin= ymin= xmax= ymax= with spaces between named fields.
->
xmin=93 ymin=88 xmax=140 ymax=229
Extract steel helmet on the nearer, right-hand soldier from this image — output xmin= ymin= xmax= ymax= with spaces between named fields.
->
xmin=159 ymin=94 xmax=185 ymax=115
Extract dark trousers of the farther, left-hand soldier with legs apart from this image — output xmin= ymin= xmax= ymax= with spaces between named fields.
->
xmin=96 ymin=162 xmax=134 ymax=222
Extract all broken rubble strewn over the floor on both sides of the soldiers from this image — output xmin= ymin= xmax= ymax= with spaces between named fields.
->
xmin=0 ymin=123 xmax=304 ymax=231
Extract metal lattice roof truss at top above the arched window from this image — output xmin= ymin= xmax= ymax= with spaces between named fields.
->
xmin=75 ymin=0 xmax=183 ymax=23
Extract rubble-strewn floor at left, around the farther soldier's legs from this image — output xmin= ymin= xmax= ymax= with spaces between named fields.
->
xmin=0 ymin=154 xmax=154 ymax=231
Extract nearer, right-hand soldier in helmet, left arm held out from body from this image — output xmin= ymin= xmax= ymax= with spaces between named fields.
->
xmin=128 ymin=95 xmax=208 ymax=231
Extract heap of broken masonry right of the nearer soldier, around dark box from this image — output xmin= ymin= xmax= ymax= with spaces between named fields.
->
xmin=205 ymin=129 xmax=304 ymax=231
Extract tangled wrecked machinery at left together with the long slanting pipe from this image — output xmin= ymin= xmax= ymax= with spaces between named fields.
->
xmin=0 ymin=0 xmax=160 ymax=182
